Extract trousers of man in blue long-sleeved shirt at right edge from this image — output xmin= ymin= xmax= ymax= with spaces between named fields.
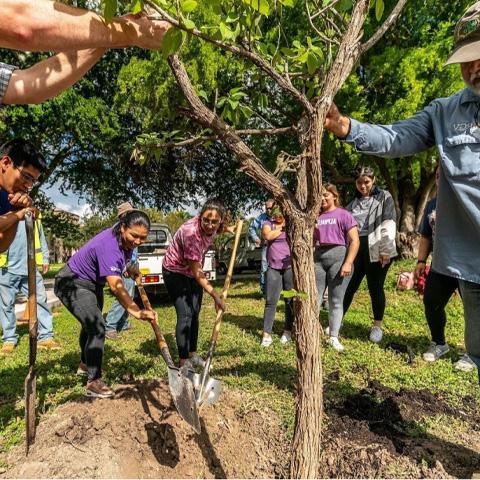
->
xmin=458 ymin=280 xmax=480 ymax=378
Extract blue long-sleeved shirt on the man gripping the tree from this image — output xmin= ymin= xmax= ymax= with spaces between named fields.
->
xmin=346 ymin=88 xmax=480 ymax=283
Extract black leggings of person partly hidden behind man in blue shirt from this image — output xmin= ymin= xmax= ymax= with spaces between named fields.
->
xmin=423 ymin=270 xmax=458 ymax=345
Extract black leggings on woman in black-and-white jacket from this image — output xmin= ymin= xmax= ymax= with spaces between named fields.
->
xmin=343 ymin=236 xmax=392 ymax=320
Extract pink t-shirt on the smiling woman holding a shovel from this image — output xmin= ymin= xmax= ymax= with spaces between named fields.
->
xmin=162 ymin=216 xmax=216 ymax=277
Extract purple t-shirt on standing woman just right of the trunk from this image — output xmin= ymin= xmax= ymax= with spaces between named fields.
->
xmin=313 ymin=208 xmax=358 ymax=245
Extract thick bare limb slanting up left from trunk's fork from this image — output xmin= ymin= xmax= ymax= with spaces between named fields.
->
xmin=168 ymin=55 xmax=296 ymax=209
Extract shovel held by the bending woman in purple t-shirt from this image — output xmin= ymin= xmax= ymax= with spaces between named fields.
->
xmin=128 ymin=265 xmax=202 ymax=433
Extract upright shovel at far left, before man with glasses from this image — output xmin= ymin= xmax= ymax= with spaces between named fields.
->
xmin=25 ymin=212 xmax=38 ymax=455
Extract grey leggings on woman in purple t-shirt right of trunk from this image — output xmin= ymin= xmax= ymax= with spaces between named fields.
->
xmin=315 ymin=245 xmax=353 ymax=337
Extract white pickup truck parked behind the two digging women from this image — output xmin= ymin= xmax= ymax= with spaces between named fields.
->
xmin=138 ymin=223 xmax=216 ymax=295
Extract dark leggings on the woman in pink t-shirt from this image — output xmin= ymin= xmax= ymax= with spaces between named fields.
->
xmin=163 ymin=268 xmax=203 ymax=360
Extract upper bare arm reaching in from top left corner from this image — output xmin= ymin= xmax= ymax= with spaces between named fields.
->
xmin=0 ymin=0 xmax=170 ymax=52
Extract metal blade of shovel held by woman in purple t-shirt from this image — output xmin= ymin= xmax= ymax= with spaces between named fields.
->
xmin=168 ymin=367 xmax=202 ymax=433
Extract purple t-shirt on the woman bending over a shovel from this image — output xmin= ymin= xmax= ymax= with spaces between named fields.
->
xmin=68 ymin=227 xmax=132 ymax=285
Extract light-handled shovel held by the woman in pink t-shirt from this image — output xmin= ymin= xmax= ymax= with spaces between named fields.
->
xmin=192 ymin=220 xmax=243 ymax=406
